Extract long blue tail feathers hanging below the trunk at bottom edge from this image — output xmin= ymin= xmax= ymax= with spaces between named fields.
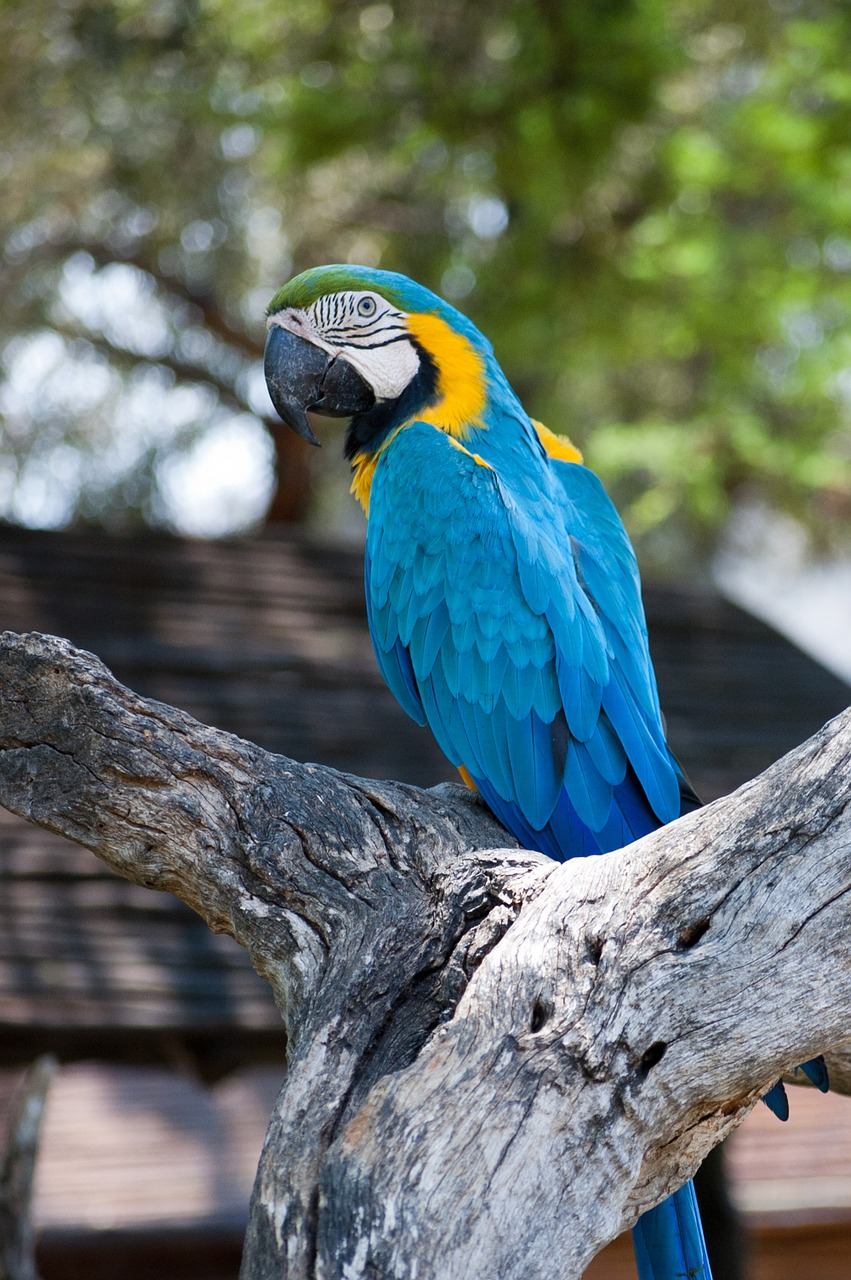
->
xmin=632 ymin=1183 xmax=712 ymax=1280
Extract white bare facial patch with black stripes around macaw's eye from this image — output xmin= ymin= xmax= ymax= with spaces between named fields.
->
xmin=269 ymin=292 xmax=420 ymax=401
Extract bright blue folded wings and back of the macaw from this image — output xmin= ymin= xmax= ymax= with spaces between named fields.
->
xmin=366 ymin=424 xmax=680 ymax=859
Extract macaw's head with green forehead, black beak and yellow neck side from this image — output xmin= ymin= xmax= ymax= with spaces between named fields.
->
xmin=265 ymin=266 xmax=493 ymax=463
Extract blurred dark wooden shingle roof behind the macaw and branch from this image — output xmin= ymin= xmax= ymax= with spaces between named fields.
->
xmin=0 ymin=527 xmax=850 ymax=1079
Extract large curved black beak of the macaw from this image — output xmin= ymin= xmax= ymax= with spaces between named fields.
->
xmin=264 ymin=324 xmax=375 ymax=444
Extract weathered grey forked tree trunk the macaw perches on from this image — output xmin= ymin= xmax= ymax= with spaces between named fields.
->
xmin=0 ymin=634 xmax=851 ymax=1280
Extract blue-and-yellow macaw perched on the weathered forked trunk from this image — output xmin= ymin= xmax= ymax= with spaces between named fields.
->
xmin=265 ymin=266 xmax=824 ymax=1280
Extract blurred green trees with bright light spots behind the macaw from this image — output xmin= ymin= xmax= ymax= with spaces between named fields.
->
xmin=0 ymin=0 xmax=851 ymax=566
